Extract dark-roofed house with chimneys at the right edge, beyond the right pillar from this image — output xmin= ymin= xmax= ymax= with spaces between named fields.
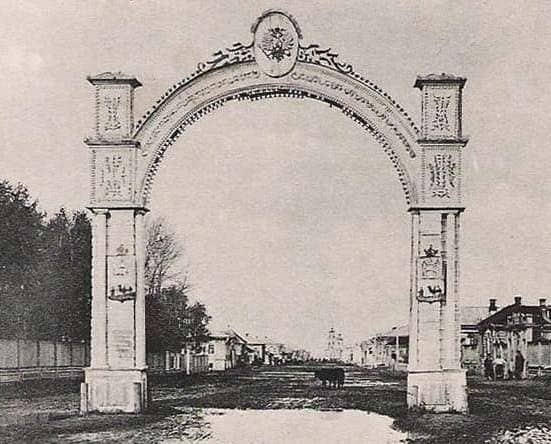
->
xmin=478 ymin=296 xmax=551 ymax=378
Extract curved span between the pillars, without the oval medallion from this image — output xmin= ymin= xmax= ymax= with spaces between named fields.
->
xmin=133 ymin=56 xmax=421 ymax=206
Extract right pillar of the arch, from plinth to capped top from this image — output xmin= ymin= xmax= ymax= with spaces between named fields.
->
xmin=407 ymin=74 xmax=468 ymax=412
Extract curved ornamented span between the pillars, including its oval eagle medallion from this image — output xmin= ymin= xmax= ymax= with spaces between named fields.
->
xmin=134 ymin=10 xmax=420 ymax=204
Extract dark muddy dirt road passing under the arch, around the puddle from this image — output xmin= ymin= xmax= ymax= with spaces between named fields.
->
xmin=0 ymin=366 xmax=551 ymax=444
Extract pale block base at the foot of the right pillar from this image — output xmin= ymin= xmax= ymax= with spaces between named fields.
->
xmin=407 ymin=369 xmax=468 ymax=413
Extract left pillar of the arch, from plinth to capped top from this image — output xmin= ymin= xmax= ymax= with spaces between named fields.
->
xmin=81 ymin=73 xmax=147 ymax=413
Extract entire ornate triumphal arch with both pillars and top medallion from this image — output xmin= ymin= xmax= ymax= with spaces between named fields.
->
xmin=81 ymin=10 xmax=467 ymax=412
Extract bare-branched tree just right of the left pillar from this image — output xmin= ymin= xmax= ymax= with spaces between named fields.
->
xmin=145 ymin=218 xmax=183 ymax=295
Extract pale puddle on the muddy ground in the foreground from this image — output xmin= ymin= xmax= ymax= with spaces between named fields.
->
xmin=55 ymin=408 xmax=408 ymax=444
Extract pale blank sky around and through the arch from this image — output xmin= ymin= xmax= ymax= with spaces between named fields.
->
xmin=0 ymin=0 xmax=551 ymax=349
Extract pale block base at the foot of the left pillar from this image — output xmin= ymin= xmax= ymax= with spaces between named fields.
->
xmin=80 ymin=368 xmax=148 ymax=414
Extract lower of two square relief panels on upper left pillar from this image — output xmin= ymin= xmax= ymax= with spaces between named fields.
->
xmin=92 ymin=147 xmax=135 ymax=206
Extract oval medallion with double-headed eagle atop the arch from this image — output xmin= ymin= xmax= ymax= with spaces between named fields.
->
xmin=254 ymin=11 xmax=299 ymax=77
